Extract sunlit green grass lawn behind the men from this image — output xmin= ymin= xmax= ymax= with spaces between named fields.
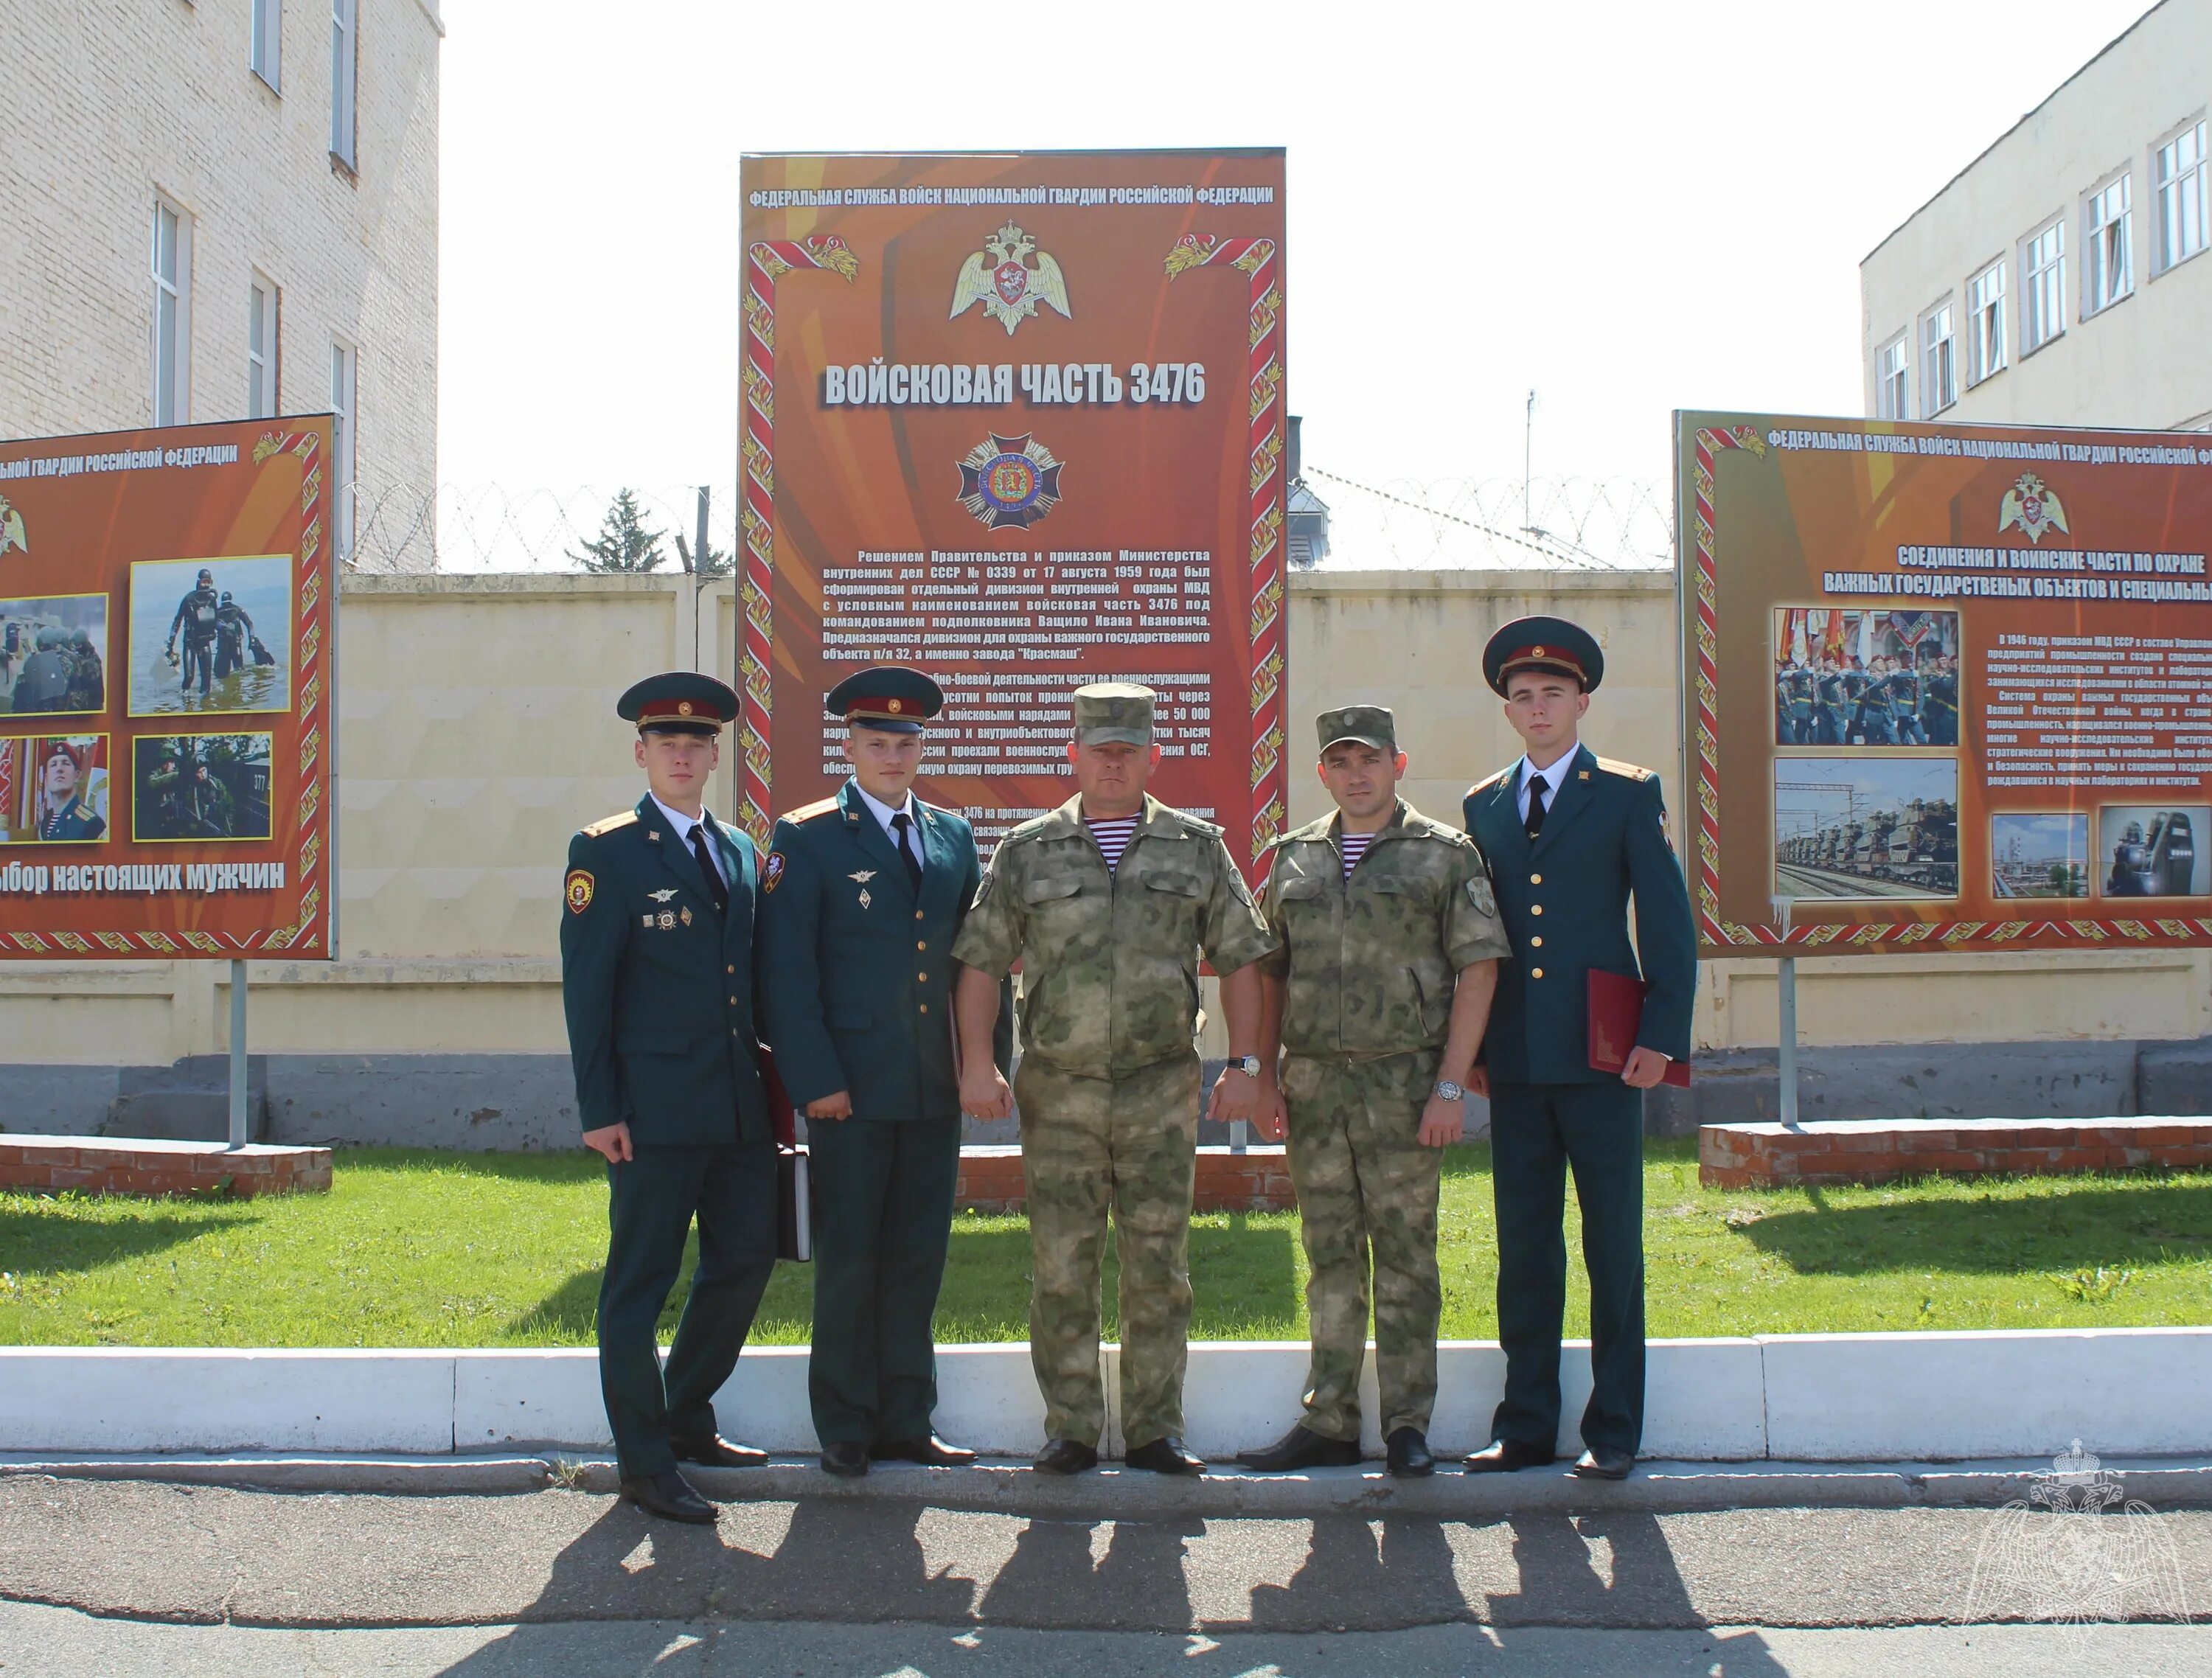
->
xmin=0 ymin=1141 xmax=2212 ymax=1346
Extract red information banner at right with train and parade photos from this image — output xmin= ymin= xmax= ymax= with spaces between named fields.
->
xmin=1674 ymin=414 xmax=2212 ymax=955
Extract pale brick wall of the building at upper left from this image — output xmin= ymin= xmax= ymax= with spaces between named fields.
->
xmin=0 ymin=0 xmax=445 ymax=568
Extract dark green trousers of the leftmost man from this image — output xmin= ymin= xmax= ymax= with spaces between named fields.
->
xmin=599 ymin=1141 xmax=776 ymax=1479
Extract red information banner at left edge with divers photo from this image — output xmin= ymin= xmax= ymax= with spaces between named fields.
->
xmin=0 ymin=416 xmax=338 ymax=961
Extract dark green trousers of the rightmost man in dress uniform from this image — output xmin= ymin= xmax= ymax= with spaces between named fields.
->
xmin=1491 ymin=1083 xmax=1644 ymax=1452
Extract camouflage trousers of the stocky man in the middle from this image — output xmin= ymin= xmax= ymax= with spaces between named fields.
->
xmin=1013 ymin=1054 xmax=1199 ymax=1448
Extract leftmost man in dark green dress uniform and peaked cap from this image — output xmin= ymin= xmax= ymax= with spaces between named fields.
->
xmin=560 ymin=670 xmax=776 ymax=1525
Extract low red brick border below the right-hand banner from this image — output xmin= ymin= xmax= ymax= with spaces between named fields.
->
xmin=1697 ymin=1118 xmax=2212 ymax=1189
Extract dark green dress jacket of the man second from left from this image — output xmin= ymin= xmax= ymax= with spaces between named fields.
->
xmin=759 ymin=781 xmax=982 ymax=1121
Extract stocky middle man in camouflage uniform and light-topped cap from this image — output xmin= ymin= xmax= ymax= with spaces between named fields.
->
xmin=953 ymin=683 xmax=1274 ymax=1475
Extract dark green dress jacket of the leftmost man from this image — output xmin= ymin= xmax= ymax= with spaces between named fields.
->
xmin=560 ymin=796 xmax=772 ymax=1143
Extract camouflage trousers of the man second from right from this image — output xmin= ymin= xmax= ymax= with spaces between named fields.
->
xmin=1283 ymin=1050 xmax=1444 ymax=1439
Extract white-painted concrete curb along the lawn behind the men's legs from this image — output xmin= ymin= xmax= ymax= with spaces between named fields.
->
xmin=0 ymin=1329 xmax=2212 ymax=1463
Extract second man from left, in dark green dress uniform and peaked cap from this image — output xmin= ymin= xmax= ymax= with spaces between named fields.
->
xmin=761 ymin=668 xmax=1004 ymax=1477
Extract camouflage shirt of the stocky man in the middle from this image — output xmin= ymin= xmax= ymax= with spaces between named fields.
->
xmin=953 ymin=798 xmax=1274 ymax=1079
